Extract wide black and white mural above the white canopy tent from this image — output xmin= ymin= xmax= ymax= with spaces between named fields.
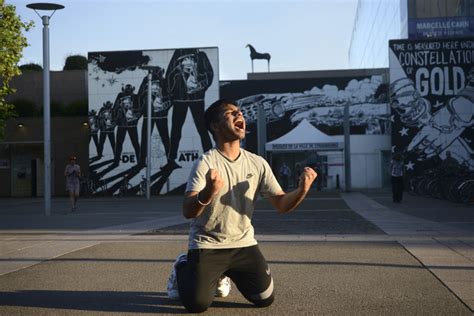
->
xmin=221 ymin=74 xmax=390 ymax=152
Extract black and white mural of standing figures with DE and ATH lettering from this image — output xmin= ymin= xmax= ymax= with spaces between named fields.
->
xmin=88 ymin=47 xmax=219 ymax=196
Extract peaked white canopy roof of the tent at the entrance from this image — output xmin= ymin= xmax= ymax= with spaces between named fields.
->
xmin=265 ymin=119 xmax=344 ymax=152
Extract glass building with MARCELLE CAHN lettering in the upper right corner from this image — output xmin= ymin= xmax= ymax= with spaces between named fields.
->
xmin=348 ymin=0 xmax=474 ymax=68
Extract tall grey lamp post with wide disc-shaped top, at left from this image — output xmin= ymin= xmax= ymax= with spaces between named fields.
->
xmin=26 ymin=3 xmax=64 ymax=216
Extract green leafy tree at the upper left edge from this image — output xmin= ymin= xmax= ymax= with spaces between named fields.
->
xmin=0 ymin=0 xmax=33 ymax=139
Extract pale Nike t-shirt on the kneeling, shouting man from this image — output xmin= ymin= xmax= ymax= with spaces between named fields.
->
xmin=186 ymin=148 xmax=281 ymax=249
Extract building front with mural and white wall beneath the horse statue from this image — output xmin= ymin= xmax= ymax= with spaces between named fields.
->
xmin=230 ymin=69 xmax=391 ymax=189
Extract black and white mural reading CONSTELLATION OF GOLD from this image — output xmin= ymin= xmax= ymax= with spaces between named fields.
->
xmin=389 ymin=38 xmax=474 ymax=201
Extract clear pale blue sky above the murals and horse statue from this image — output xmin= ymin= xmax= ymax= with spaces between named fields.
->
xmin=9 ymin=0 xmax=357 ymax=80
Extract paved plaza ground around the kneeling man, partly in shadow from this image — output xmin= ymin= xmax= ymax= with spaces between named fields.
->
xmin=0 ymin=190 xmax=474 ymax=315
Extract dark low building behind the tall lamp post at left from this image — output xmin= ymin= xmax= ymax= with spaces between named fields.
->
xmin=0 ymin=70 xmax=89 ymax=197
